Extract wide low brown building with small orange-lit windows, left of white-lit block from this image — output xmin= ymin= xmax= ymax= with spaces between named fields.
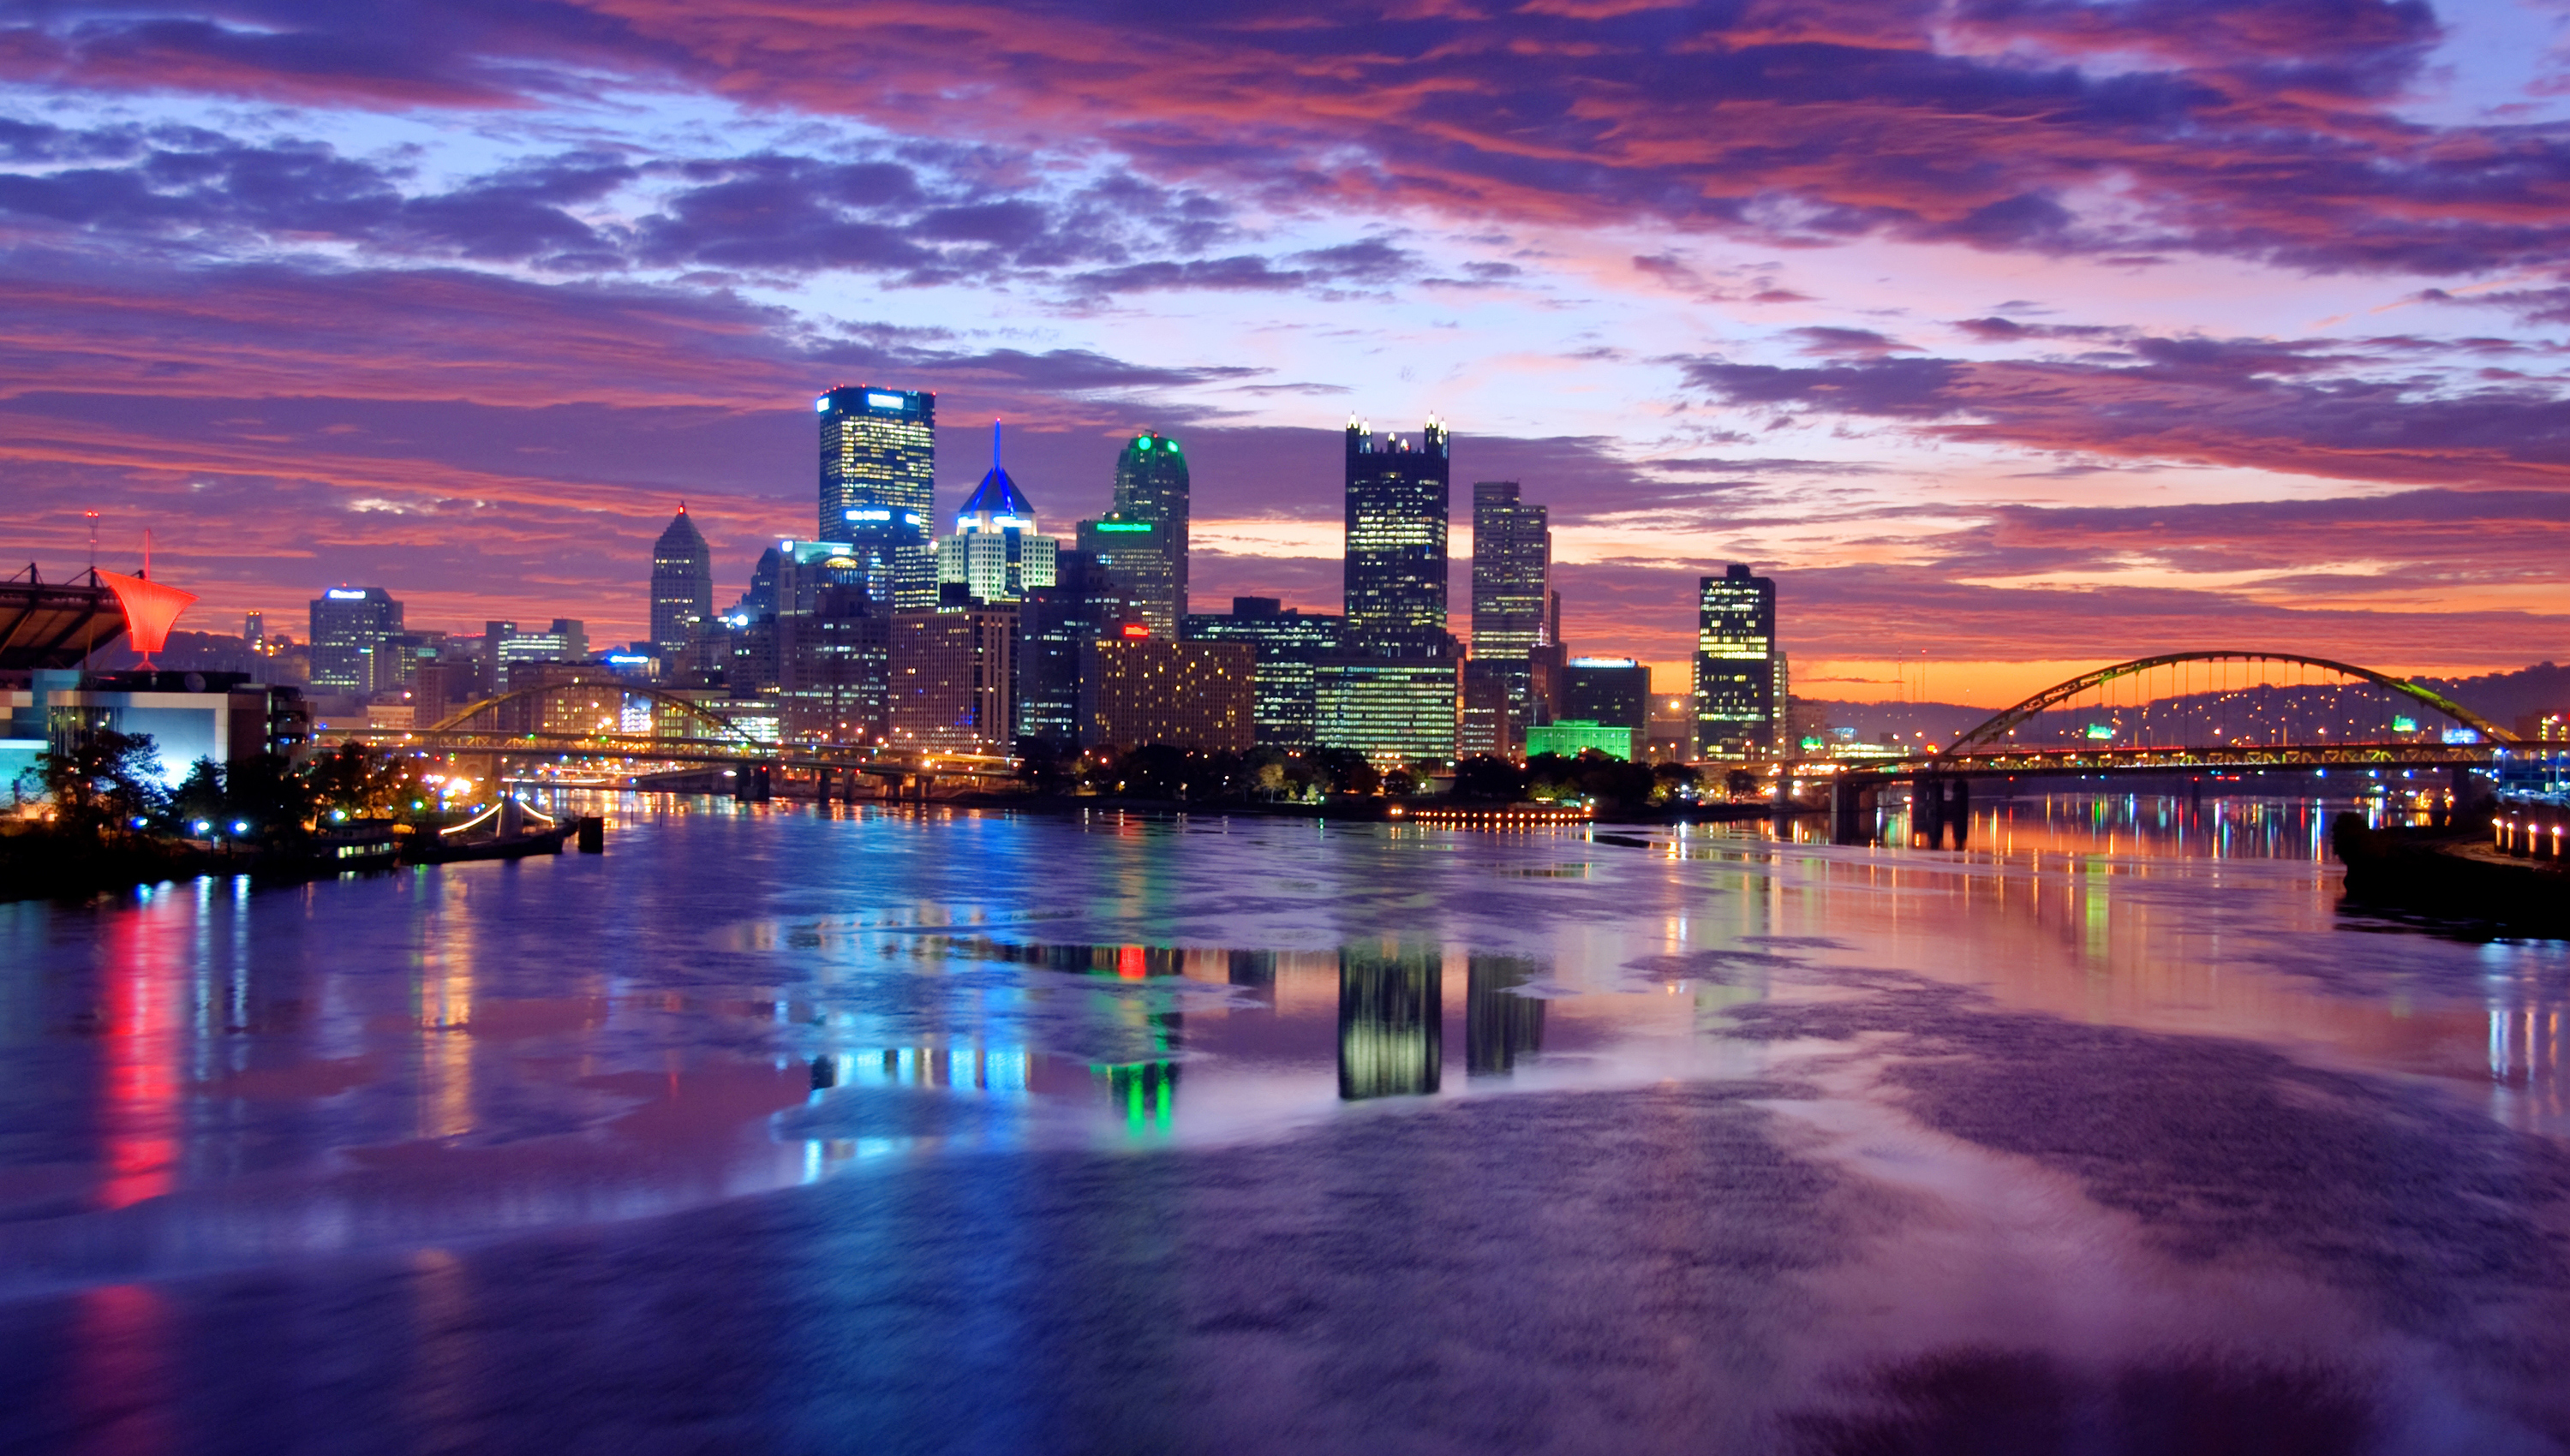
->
xmin=1079 ymin=637 xmax=1257 ymax=752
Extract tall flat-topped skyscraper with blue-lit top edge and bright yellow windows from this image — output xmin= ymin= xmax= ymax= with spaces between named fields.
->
xmin=812 ymin=385 xmax=938 ymax=609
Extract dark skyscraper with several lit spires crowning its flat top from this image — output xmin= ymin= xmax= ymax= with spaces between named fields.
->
xmin=1347 ymin=416 xmax=1452 ymax=658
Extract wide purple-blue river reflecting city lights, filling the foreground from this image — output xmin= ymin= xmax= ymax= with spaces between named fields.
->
xmin=0 ymin=796 xmax=2570 ymax=1453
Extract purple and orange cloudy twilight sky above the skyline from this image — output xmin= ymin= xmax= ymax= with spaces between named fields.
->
xmin=0 ymin=0 xmax=2570 ymax=707
